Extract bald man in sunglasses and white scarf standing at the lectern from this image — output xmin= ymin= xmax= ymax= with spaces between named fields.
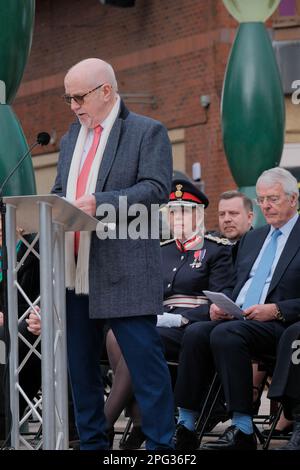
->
xmin=52 ymin=59 xmax=174 ymax=450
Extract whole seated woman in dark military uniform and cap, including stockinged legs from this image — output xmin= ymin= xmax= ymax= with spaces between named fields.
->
xmin=105 ymin=179 xmax=232 ymax=449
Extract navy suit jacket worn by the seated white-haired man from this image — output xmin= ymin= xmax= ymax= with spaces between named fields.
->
xmin=231 ymin=218 xmax=300 ymax=323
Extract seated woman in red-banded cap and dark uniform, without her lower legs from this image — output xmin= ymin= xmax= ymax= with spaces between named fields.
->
xmin=157 ymin=180 xmax=232 ymax=360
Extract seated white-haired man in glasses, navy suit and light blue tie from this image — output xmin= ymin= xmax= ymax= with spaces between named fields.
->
xmin=175 ymin=168 xmax=300 ymax=450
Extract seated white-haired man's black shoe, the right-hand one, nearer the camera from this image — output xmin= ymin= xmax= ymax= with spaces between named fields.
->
xmin=200 ymin=426 xmax=257 ymax=450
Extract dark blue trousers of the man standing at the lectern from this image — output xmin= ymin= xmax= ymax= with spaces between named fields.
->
xmin=67 ymin=291 xmax=174 ymax=450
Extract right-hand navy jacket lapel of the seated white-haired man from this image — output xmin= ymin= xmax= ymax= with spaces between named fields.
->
xmin=268 ymin=218 xmax=300 ymax=295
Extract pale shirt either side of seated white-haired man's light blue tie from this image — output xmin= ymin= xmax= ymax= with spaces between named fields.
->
xmin=235 ymin=214 xmax=298 ymax=306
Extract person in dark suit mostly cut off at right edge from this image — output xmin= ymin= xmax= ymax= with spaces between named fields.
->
xmin=268 ymin=322 xmax=300 ymax=450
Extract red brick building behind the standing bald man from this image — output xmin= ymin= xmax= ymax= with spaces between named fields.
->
xmin=14 ymin=0 xmax=300 ymax=228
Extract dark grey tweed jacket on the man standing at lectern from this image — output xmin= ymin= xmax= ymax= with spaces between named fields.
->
xmin=52 ymin=102 xmax=172 ymax=318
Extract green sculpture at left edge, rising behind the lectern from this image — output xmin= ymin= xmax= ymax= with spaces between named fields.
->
xmin=0 ymin=0 xmax=36 ymax=196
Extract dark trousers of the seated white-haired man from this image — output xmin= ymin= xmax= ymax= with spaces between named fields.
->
xmin=175 ymin=320 xmax=284 ymax=415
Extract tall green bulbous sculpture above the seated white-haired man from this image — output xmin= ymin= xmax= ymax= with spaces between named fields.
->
xmin=221 ymin=0 xmax=285 ymax=226
